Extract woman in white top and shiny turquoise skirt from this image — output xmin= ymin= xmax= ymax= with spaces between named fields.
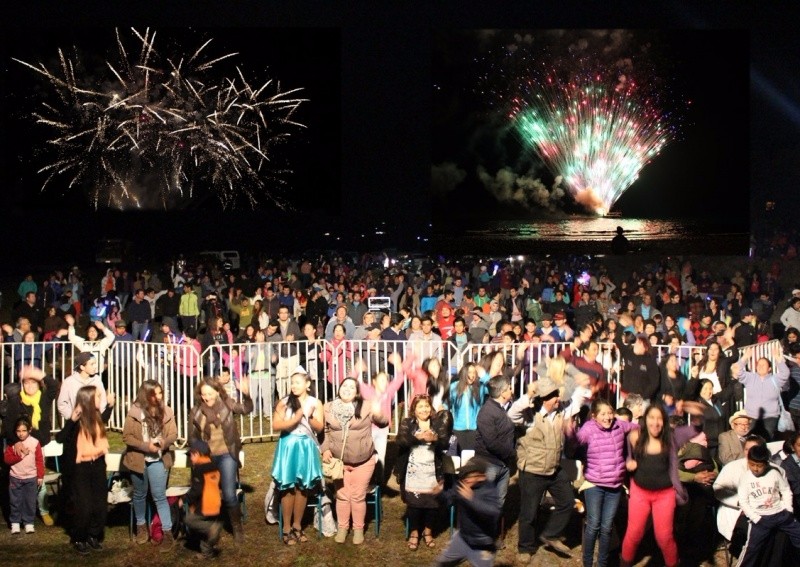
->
xmin=272 ymin=367 xmax=325 ymax=545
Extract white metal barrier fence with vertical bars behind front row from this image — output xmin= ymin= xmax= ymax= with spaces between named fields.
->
xmin=0 ymin=339 xmax=777 ymax=443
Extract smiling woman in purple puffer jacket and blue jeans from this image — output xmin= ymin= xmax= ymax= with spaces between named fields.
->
xmin=577 ymin=398 xmax=639 ymax=567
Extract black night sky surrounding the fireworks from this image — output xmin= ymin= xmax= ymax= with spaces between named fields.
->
xmin=0 ymin=1 xmax=800 ymax=268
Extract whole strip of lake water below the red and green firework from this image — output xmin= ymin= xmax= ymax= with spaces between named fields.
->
xmin=432 ymin=217 xmax=750 ymax=255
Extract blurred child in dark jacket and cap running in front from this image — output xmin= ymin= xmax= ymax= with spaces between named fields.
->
xmin=436 ymin=457 xmax=502 ymax=567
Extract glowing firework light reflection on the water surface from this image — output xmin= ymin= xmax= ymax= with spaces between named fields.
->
xmin=465 ymin=217 xmax=736 ymax=241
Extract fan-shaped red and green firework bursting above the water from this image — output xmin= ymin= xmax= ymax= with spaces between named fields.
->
xmin=510 ymin=48 xmax=675 ymax=215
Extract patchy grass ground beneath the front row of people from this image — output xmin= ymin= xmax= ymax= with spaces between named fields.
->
xmin=0 ymin=433 xmax=723 ymax=567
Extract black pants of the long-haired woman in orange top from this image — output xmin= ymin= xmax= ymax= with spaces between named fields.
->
xmin=70 ymin=457 xmax=108 ymax=541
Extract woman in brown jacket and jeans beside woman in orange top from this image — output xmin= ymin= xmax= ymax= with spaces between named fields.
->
xmin=122 ymin=380 xmax=178 ymax=553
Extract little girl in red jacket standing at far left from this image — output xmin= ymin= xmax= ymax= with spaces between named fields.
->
xmin=4 ymin=417 xmax=44 ymax=534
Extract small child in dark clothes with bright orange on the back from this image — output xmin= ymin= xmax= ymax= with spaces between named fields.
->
xmin=184 ymin=439 xmax=222 ymax=559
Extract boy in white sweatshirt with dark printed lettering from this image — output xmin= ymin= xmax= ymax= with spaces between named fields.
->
xmin=737 ymin=445 xmax=800 ymax=567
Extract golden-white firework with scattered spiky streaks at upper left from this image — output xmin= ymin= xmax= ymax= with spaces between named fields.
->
xmin=15 ymin=29 xmax=306 ymax=209
